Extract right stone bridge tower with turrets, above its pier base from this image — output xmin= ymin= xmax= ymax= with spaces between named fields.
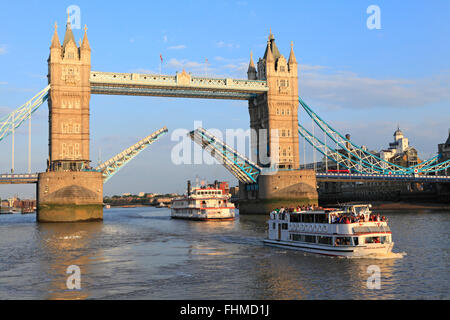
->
xmin=248 ymin=32 xmax=300 ymax=169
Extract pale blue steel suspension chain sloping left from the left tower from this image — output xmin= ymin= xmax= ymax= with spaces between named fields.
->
xmin=0 ymin=85 xmax=50 ymax=141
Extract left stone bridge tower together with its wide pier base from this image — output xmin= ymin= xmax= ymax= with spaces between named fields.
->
xmin=36 ymin=18 xmax=103 ymax=222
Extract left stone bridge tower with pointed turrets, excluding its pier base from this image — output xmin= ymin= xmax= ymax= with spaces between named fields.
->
xmin=48 ymin=17 xmax=91 ymax=171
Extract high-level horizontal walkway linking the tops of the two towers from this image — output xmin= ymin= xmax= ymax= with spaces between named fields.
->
xmin=89 ymin=71 xmax=269 ymax=100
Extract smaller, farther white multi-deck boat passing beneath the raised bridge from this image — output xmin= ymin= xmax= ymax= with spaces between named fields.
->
xmin=171 ymin=181 xmax=234 ymax=220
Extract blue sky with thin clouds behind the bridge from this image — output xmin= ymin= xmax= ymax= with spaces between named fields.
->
xmin=0 ymin=0 xmax=450 ymax=197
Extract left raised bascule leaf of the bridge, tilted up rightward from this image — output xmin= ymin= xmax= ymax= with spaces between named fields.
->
xmin=95 ymin=127 xmax=168 ymax=183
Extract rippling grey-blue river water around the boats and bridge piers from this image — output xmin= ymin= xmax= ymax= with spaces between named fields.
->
xmin=0 ymin=207 xmax=450 ymax=299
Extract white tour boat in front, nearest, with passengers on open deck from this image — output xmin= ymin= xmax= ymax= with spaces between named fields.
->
xmin=264 ymin=204 xmax=394 ymax=257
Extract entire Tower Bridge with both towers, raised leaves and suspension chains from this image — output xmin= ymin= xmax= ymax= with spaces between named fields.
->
xmin=0 ymin=13 xmax=450 ymax=222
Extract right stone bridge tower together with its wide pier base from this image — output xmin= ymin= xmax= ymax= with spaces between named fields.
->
xmin=239 ymin=32 xmax=318 ymax=214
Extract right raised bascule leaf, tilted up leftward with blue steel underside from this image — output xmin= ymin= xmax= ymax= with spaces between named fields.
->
xmin=188 ymin=128 xmax=261 ymax=184
